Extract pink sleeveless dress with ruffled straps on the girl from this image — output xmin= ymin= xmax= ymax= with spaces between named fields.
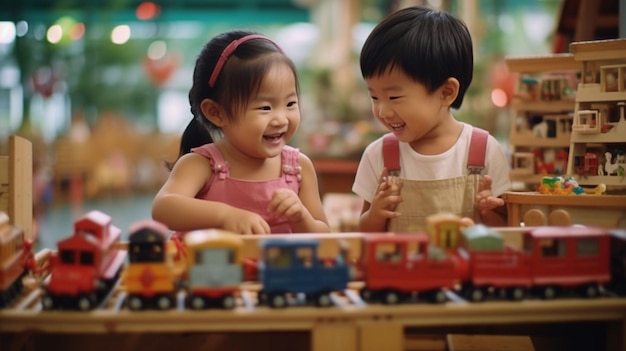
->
xmin=191 ymin=144 xmax=301 ymax=234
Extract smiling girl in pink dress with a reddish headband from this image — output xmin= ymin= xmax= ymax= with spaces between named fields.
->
xmin=152 ymin=31 xmax=329 ymax=234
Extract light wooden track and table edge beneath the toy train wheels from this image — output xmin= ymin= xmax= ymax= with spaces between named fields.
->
xmin=0 ymin=282 xmax=626 ymax=333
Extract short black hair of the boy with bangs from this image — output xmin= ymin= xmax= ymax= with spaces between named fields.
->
xmin=361 ymin=6 xmax=474 ymax=109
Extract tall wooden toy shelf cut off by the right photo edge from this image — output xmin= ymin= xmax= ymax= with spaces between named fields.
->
xmin=567 ymin=39 xmax=626 ymax=191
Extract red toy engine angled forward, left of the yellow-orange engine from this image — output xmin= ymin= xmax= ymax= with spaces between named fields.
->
xmin=41 ymin=211 xmax=126 ymax=310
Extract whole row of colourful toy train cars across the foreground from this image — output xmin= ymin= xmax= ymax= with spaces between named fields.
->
xmin=0 ymin=211 xmax=626 ymax=310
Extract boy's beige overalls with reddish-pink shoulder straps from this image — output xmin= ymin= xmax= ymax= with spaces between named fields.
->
xmin=383 ymin=128 xmax=488 ymax=232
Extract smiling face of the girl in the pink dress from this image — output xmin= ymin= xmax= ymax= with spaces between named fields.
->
xmin=222 ymin=63 xmax=300 ymax=158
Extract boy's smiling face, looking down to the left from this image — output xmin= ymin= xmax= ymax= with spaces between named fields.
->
xmin=365 ymin=68 xmax=449 ymax=143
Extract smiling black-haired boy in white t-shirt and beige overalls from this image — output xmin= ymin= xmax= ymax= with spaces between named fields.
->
xmin=352 ymin=7 xmax=510 ymax=232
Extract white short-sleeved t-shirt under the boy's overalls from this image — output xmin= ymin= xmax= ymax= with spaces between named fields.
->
xmin=352 ymin=123 xmax=511 ymax=203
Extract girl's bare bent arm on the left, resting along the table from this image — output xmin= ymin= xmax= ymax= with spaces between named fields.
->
xmin=152 ymin=153 xmax=270 ymax=234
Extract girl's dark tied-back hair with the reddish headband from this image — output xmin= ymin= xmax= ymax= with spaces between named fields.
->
xmin=166 ymin=30 xmax=299 ymax=169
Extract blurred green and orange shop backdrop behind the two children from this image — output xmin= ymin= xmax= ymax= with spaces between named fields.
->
xmin=0 ymin=0 xmax=619 ymax=247
